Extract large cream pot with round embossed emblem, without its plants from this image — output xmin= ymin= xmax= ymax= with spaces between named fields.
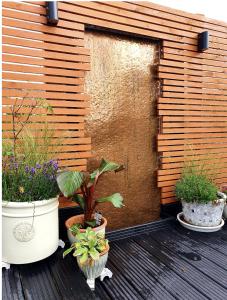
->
xmin=2 ymin=198 xmax=59 ymax=264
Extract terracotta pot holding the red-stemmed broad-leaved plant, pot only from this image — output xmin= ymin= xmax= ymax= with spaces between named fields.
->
xmin=65 ymin=215 xmax=107 ymax=244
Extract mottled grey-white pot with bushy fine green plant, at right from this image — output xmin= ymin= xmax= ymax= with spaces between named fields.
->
xmin=175 ymin=164 xmax=225 ymax=227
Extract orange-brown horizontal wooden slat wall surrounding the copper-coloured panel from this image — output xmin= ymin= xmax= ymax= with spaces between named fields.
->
xmin=3 ymin=1 xmax=227 ymax=204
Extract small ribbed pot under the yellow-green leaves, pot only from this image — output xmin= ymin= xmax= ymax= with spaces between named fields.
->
xmin=77 ymin=245 xmax=110 ymax=279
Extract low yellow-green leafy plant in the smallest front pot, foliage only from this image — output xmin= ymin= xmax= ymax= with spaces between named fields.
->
xmin=63 ymin=227 xmax=109 ymax=265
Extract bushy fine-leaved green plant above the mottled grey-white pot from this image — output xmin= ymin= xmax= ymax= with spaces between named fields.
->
xmin=175 ymin=162 xmax=218 ymax=204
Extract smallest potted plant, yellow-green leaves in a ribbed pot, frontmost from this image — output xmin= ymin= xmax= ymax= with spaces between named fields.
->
xmin=63 ymin=227 xmax=109 ymax=279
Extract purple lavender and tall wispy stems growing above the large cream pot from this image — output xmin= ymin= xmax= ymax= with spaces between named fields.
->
xmin=2 ymin=95 xmax=59 ymax=202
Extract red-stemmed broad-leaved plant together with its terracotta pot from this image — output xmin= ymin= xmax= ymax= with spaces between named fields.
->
xmin=57 ymin=159 xmax=123 ymax=243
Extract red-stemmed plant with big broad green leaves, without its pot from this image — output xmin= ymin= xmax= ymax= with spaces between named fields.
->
xmin=57 ymin=159 xmax=123 ymax=228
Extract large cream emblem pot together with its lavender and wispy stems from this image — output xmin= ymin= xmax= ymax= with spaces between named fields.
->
xmin=2 ymin=100 xmax=59 ymax=264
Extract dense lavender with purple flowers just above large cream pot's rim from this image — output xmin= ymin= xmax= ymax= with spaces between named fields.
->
xmin=2 ymin=157 xmax=59 ymax=202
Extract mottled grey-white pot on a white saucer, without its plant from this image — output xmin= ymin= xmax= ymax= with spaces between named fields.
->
xmin=182 ymin=199 xmax=225 ymax=227
